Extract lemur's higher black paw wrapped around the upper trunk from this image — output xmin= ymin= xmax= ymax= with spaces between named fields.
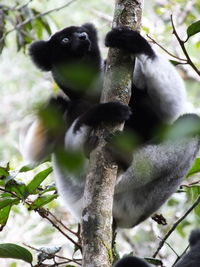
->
xmin=105 ymin=27 xmax=154 ymax=56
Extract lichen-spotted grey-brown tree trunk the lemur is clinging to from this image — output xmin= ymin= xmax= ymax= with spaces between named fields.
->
xmin=82 ymin=0 xmax=143 ymax=267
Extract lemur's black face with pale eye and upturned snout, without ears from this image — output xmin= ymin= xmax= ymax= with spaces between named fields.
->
xmin=48 ymin=26 xmax=91 ymax=63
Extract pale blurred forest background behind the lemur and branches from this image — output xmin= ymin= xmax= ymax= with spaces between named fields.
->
xmin=0 ymin=0 xmax=200 ymax=267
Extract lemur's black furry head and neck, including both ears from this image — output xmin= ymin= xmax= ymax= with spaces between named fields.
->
xmin=29 ymin=23 xmax=101 ymax=101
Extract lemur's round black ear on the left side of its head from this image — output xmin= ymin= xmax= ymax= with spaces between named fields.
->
xmin=29 ymin=41 xmax=52 ymax=71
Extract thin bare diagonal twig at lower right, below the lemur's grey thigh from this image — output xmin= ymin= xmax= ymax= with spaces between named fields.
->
xmin=153 ymin=195 xmax=200 ymax=258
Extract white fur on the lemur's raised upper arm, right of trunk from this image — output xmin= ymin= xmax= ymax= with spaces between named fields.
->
xmin=134 ymin=54 xmax=186 ymax=122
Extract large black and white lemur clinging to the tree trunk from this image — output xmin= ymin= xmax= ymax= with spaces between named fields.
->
xmin=22 ymin=24 xmax=199 ymax=228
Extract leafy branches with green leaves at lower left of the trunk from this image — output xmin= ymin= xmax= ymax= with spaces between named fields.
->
xmin=0 ymin=165 xmax=82 ymax=267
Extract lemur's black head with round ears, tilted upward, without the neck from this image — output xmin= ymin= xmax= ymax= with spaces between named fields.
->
xmin=29 ymin=23 xmax=99 ymax=71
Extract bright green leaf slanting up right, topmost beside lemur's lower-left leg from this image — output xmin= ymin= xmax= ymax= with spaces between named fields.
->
xmin=27 ymin=167 xmax=52 ymax=194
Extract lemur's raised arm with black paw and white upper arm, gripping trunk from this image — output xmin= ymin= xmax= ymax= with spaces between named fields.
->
xmin=105 ymin=28 xmax=186 ymax=121
